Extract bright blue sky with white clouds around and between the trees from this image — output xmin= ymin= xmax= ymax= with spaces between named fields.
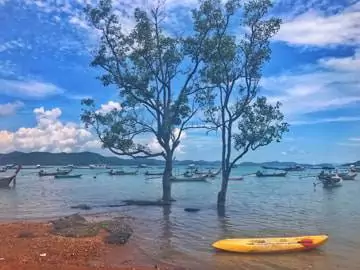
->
xmin=0 ymin=0 xmax=360 ymax=163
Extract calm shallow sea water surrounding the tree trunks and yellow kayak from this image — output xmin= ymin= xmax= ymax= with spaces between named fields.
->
xmin=0 ymin=167 xmax=360 ymax=269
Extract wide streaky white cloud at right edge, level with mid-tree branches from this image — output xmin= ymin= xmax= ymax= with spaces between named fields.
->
xmin=262 ymin=48 xmax=360 ymax=118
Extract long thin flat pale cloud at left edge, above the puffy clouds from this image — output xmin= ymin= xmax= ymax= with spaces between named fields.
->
xmin=0 ymin=79 xmax=64 ymax=98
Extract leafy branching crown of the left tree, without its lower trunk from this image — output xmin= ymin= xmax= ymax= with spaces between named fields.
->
xmin=81 ymin=0 xmax=210 ymax=159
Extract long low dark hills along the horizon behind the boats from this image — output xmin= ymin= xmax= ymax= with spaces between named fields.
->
xmin=0 ymin=152 xmax=342 ymax=167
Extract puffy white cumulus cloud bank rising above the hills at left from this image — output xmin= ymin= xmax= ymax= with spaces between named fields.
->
xmin=0 ymin=107 xmax=99 ymax=152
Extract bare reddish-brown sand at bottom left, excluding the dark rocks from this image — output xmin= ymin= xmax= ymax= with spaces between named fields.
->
xmin=0 ymin=221 xmax=184 ymax=270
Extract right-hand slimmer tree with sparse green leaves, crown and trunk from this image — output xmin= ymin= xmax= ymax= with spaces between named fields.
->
xmin=195 ymin=0 xmax=288 ymax=208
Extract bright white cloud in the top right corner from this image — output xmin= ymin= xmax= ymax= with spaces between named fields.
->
xmin=274 ymin=3 xmax=360 ymax=47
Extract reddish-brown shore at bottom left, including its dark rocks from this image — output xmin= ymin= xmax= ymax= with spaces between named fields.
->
xmin=0 ymin=214 xmax=184 ymax=270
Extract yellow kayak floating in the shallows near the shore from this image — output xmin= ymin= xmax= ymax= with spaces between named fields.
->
xmin=212 ymin=235 xmax=328 ymax=253
